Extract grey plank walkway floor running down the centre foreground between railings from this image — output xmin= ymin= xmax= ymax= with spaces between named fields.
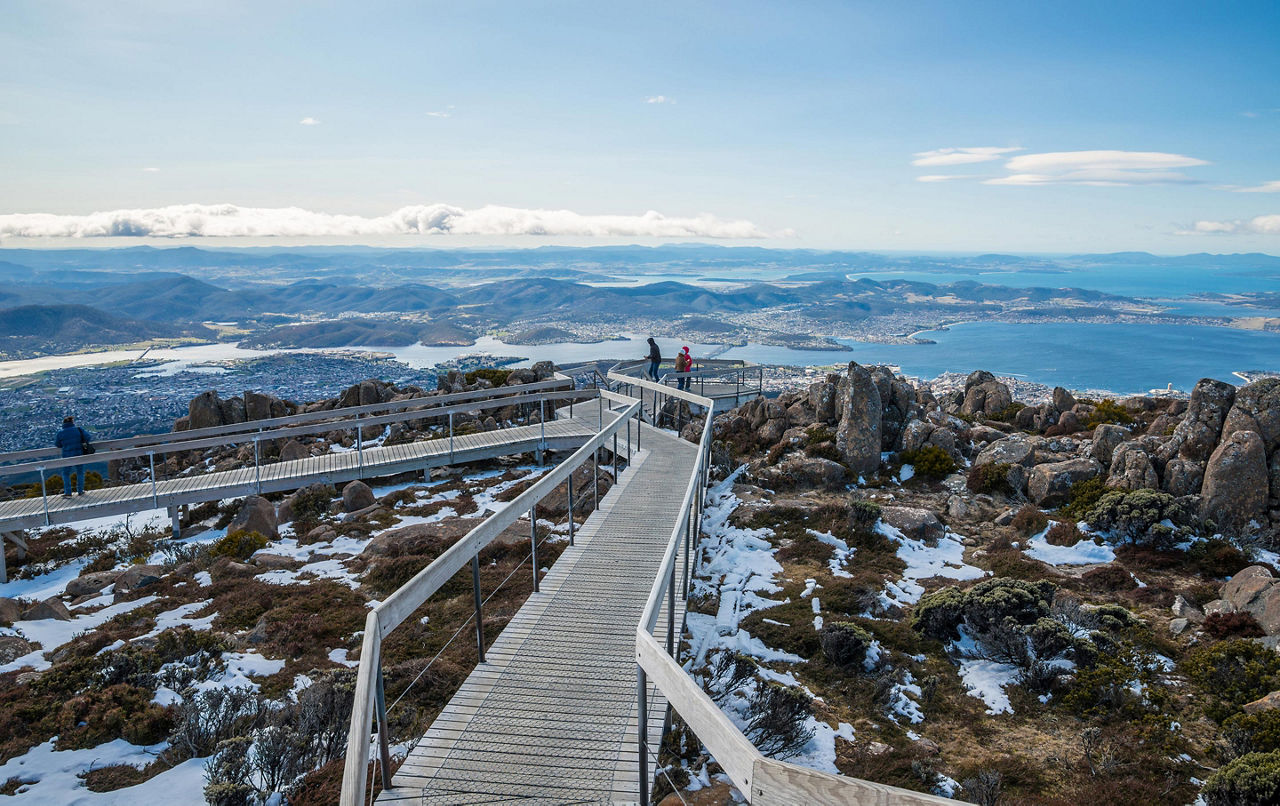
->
xmin=378 ymin=426 xmax=698 ymax=806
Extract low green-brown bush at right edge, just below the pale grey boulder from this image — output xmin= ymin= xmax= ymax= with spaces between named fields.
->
xmin=1183 ymin=638 xmax=1280 ymax=722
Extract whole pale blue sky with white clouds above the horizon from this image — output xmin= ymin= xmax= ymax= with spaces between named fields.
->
xmin=0 ymin=0 xmax=1280 ymax=253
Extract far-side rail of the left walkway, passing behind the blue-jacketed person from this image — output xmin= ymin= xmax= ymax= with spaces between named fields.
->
xmin=0 ymin=372 xmax=573 ymax=470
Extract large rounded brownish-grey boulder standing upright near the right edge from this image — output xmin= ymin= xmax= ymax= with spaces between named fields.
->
xmin=1201 ymin=431 xmax=1270 ymax=532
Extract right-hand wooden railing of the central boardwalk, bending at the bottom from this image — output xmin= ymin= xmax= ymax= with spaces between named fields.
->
xmin=634 ymin=380 xmax=955 ymax=806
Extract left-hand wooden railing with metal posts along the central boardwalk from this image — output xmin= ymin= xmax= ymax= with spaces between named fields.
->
xmin=340 ymin=389 xmax=640 ymax=806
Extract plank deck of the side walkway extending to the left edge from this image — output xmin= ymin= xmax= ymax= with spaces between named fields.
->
xmin=0 ymin=416 xmax=599 ymax=532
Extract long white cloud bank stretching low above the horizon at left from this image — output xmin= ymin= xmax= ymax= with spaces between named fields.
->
xmin=0 ymin=205 xmax=778 ymax=238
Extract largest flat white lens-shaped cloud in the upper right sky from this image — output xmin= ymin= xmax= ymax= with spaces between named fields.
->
xmin=986 ymin=151 xmax=1208 ymax=186
